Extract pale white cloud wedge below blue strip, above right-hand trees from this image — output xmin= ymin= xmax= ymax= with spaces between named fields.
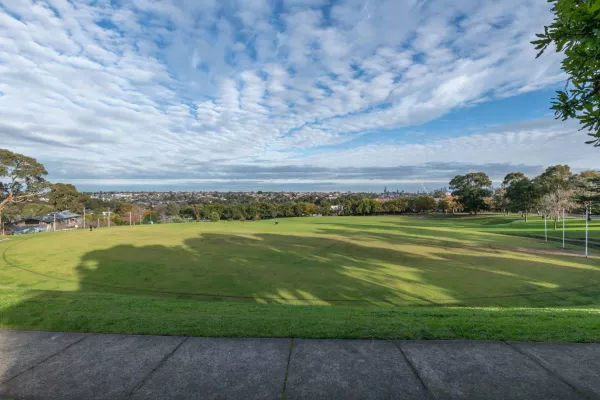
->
xmin=296 ymin=120 xmax=597 ymax=178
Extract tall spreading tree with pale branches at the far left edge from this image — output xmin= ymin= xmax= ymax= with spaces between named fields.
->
xmin=0 ymin=149 xmax=48 ymax=214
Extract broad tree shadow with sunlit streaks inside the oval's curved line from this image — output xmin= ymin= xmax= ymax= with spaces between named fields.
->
xmin=4 ymin=230 xmax=600 ymax=307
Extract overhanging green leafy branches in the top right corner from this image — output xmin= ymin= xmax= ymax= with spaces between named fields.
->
xmin=532 ymin=0 xmax=600 ymax=146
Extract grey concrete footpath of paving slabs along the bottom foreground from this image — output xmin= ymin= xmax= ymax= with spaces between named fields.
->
xmin=0 ymin=330 xmax=600 ymax=400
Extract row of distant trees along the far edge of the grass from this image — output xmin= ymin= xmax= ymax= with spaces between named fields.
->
xmin=0 ymin=149 xmax=600 ymax=230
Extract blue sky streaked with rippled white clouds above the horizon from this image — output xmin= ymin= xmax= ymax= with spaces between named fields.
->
xmin=0 ymin=0 xmax=597 ymax=190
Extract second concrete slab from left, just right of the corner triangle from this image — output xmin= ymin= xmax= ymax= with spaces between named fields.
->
xmin=0 ymin=335 xmax=184 ymax=400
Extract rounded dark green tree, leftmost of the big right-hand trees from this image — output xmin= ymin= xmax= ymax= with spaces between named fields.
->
xmin=450 ymin=172 xmax=492 ymax=215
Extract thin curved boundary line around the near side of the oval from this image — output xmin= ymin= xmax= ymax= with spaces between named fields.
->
xmin=2 ymin=239 xmax=600 ymax=307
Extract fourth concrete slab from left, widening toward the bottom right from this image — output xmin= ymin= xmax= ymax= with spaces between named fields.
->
xmin=285 ymin=340 xmax=427 ymax=400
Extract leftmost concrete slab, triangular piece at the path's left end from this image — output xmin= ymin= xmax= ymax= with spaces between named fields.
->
xmin=0 ymin=331 xmax=86 ymax=382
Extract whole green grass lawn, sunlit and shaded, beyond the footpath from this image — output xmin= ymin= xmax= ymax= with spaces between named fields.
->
xmin=0 ymin=216 xmax=600 ymax=341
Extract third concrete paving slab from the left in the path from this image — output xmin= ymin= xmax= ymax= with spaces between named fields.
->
xmin=133 ymin=338 xmax=290 ymax=399
